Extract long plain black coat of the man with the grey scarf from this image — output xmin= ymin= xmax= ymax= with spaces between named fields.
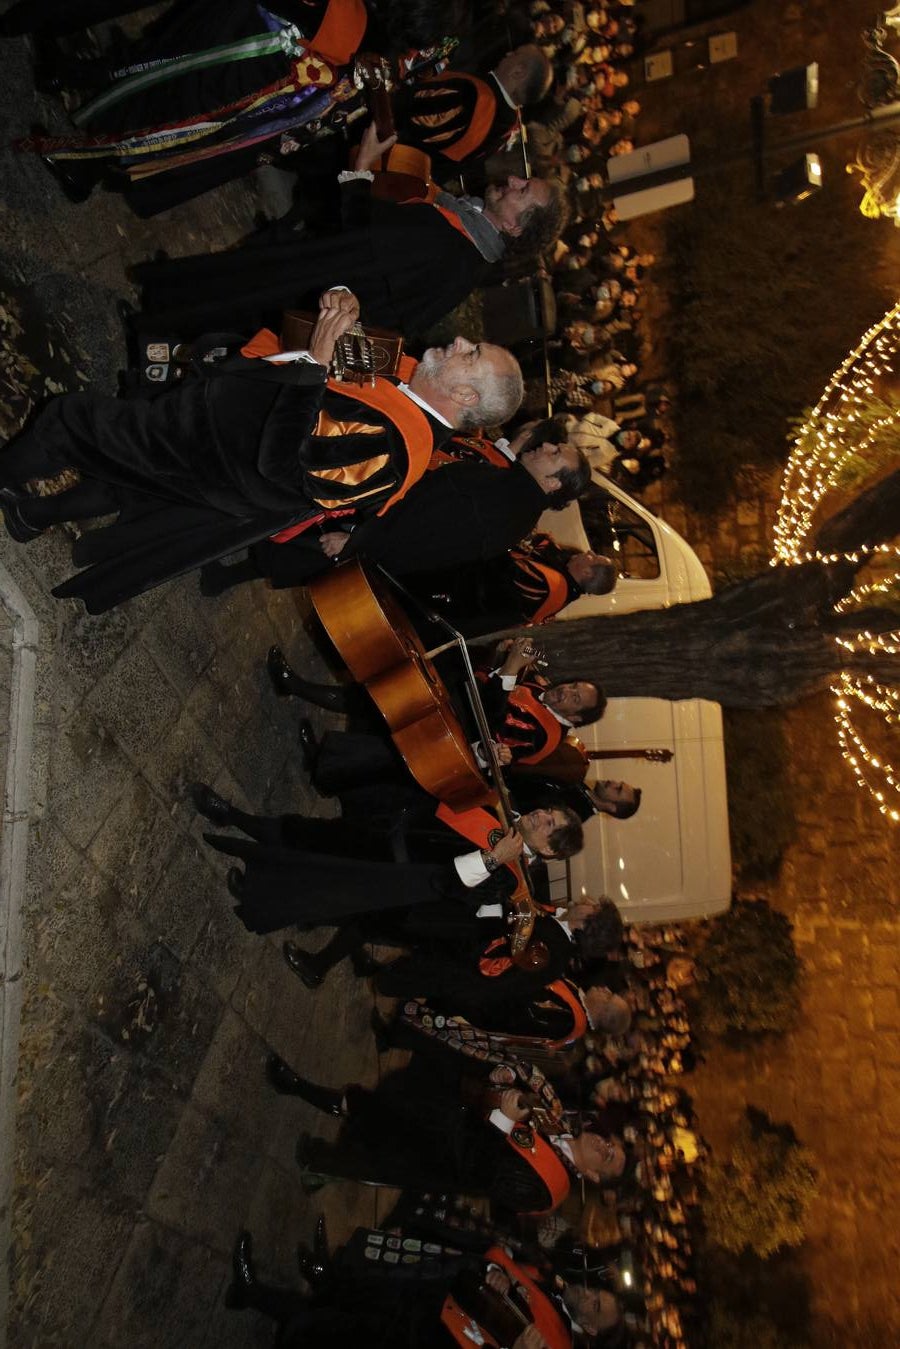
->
xmin=135 ymin=179 xmax=499 ymax=340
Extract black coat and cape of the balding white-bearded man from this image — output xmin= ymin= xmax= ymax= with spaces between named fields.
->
xmin=38 ymin=360 xmax=448 ymax=614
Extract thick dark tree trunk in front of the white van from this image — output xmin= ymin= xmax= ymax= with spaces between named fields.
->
xmin=484 ymin=469 xmax=900 ymax=707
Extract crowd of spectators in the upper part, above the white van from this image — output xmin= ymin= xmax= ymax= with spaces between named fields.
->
xmin=488 ymin=0 xmax=671 ymax=492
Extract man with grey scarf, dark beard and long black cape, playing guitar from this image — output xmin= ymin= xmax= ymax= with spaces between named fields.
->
xmin=126 ymin=127 xmax=565 ymax=351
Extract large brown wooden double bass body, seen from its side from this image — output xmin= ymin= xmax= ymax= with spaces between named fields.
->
xmin=309 ymin=561 xmax=497 ymax=811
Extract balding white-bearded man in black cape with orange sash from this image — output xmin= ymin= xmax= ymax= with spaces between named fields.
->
xmin=0 ymin=291 xmax=521 ymax=612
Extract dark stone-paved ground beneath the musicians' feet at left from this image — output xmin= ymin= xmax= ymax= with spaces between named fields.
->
xmin=0 ymin=26 xmax=394 ymax=1349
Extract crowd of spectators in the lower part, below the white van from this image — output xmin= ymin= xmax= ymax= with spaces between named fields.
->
xmin=541 ymin=927 xmax=707 ymax=1349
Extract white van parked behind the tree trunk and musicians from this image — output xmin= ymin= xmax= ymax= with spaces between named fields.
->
xmin=538 ymin=469 xmax=731 ymax=923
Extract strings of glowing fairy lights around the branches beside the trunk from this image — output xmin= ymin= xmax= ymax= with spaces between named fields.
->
xmin=770 ymin=302 xmax=900 ymax=824
